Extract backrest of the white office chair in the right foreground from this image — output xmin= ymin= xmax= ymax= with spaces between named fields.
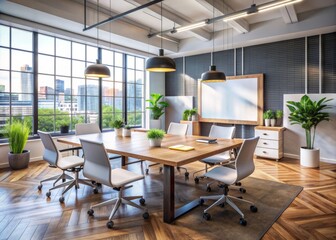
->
xmin=236 ymin=137 xmax=259 ymax=181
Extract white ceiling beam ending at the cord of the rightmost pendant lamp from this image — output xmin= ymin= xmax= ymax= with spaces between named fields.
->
xmin=125 ymin=0 xmax=211 ymax=41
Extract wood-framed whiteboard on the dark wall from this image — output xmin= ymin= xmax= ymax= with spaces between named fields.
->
xmin=199 ymin=74 xmax=263 ymax=125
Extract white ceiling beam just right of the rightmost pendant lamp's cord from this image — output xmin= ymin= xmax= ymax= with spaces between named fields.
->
xmin=195 ymin=0 xmax=250 ymax=33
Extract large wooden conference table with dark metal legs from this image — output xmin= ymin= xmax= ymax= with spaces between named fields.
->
xmin=57 ymin=132 xmax=243 ymax=223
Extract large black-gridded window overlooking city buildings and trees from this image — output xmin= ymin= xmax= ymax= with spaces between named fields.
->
xmin=0 ymin=25 xmax=145 ymax=137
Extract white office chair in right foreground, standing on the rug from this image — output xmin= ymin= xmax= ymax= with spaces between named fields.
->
xmin=200 ymin=137 xmax=259 ymax=226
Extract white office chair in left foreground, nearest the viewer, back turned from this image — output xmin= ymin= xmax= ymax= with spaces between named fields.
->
xmin=80 ymin=139 xmax=149 ymax=228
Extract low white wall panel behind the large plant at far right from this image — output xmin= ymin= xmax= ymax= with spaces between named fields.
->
xmin=283 ymin=94 xmax=336 ymax=163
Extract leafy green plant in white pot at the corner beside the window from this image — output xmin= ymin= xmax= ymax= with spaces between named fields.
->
xmin=146 ymin=93 xmax=169 ymax=128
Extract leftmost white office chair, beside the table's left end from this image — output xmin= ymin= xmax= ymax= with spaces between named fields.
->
xmin=37 ymin=131 xmax=98 ymax=203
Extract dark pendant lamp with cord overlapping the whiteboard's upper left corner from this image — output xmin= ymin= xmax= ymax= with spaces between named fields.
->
xmin=201 ymin=2 xmax=226 ymax=82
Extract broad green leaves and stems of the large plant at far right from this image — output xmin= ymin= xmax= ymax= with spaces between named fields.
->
xmin=287 ymin=95 xmax=332 ymax=149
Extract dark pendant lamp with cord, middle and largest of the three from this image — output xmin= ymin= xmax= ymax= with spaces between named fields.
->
xmin=146 ymin=2 xmax=176 ymax=72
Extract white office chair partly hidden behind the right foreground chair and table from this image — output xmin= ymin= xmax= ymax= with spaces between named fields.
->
xmin=193 ymin=125 xmax=236 ymax=184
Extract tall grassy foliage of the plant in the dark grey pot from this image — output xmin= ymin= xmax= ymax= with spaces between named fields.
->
xmin=5 ymin=120 xmax=30 ymax=154
